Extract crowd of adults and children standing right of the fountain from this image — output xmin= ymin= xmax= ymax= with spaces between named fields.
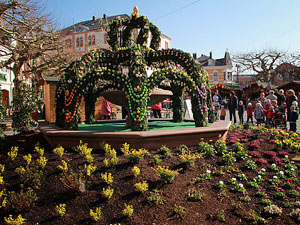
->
xmin=212 ymin=89 xmax=299 ymax=132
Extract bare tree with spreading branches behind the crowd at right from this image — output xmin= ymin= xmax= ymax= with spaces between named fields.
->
xmin=233 ymin=49 xmax=286 ymax=81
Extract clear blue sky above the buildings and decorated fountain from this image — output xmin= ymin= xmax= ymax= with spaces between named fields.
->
xmin=39 ymin=0 xmax=300 ymax=58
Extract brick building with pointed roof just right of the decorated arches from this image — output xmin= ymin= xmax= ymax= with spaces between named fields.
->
xmin=194 ymin=51 xmax=233 ymax=85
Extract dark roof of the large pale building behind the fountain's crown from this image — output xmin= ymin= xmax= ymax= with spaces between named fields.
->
xmin=62 ymin=14 xmax=129 ymax=35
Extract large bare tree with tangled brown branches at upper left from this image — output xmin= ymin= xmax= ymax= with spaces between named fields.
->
xmin=0 ymin=0 xmax=71 ymax=92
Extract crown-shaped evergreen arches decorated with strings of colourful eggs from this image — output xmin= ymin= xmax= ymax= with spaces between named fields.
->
xmin=56 ymin=9 xmax=214 ymax=131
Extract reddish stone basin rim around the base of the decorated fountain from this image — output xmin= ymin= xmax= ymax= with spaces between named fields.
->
xmin=39 ymin=120 xmax=231 ymax=149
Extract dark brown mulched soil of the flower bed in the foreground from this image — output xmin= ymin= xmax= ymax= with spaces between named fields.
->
xmin=0 ymin=128 xmax=300 ymax=225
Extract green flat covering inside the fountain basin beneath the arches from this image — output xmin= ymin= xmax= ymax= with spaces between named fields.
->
xmin=78 ymin=121 xmax=195 ymax=132
